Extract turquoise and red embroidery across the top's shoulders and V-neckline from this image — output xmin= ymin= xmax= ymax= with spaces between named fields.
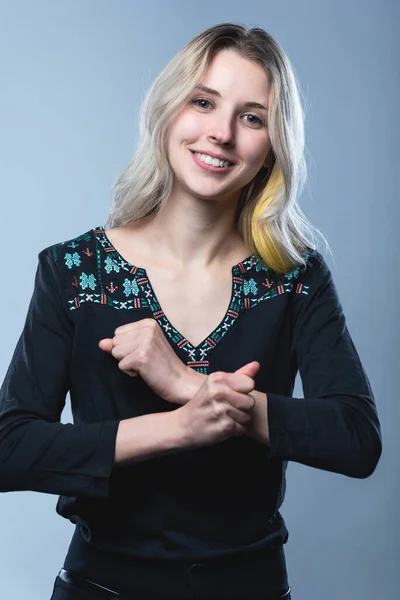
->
xmin=52 ymin=227 xmax=313 ymax=373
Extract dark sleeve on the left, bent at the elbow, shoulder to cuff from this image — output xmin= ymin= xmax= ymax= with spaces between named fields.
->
xmin=0 ymin=248 xmax=119 ymax=498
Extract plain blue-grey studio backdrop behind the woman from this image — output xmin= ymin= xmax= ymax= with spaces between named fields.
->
xmin=0 ymin=0 xmax=400 ymax=600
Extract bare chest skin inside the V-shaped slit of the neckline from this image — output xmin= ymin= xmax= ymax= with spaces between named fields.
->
xmin=147 ymin=269 xmax=232 ymax=346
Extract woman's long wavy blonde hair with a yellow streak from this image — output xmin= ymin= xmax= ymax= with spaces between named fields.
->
xmin=106 ymin=23 xmax=329 ymax=273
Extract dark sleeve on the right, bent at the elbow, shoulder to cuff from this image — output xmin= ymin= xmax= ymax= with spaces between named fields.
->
xmin=267 ymin=252 xmax=382 ymax=479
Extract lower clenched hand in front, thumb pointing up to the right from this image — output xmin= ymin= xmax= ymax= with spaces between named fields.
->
xmin=171 ymin=361 xmax=260 ymax=447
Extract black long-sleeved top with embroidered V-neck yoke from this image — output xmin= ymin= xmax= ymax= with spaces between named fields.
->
xmin=0 ymin=227 xmax=382 ymax=560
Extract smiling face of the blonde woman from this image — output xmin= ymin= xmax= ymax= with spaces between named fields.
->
xmin=168 ymin=50 xmax=270 ymax=206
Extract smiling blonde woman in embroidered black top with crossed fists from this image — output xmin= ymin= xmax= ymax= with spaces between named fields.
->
xmin=0 ymin=24 xmax=382 ymax=600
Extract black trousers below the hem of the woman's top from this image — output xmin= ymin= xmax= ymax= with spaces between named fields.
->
xmin=51 ymin=527 xmax=291 ymax=600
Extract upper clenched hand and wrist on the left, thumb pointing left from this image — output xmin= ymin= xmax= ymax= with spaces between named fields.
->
xmin=99 ymin=318 xmax=197 ymax=404
